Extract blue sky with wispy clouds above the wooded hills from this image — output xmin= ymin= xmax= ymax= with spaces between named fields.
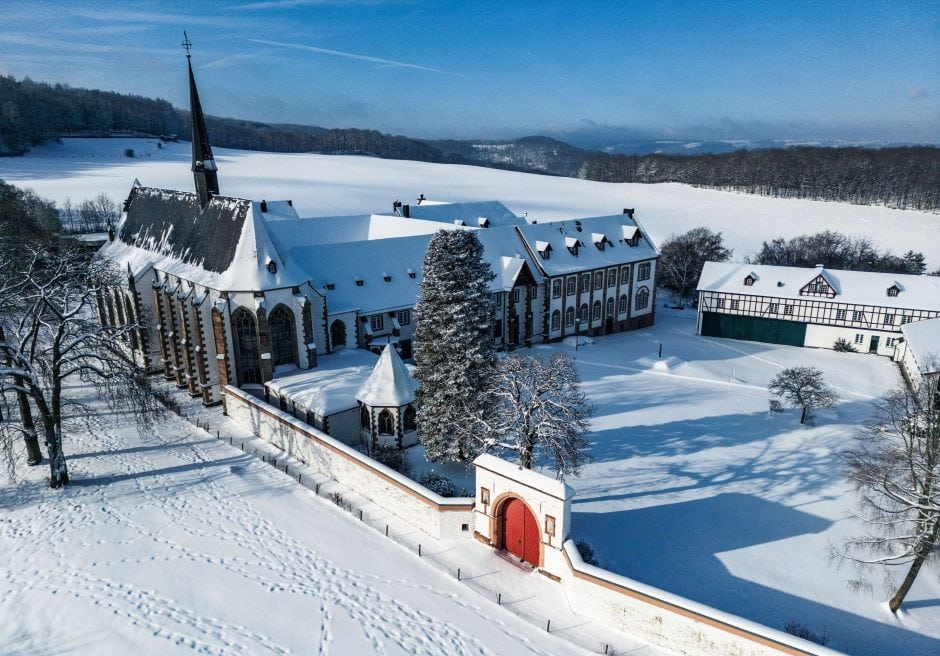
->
xmin=0 ymin=0 xmax=940 ymax=141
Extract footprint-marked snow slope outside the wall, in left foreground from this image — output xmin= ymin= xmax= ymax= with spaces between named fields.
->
xmin=0 ymin=382 xmax=648 ymax=656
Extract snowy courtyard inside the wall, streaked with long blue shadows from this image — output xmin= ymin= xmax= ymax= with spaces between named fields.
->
xmin=542 ymin=310 xmax=940 ymax=655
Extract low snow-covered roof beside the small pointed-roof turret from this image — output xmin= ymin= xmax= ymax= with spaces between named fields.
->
xmin=266 ymin=349 xmax=379 ymax=417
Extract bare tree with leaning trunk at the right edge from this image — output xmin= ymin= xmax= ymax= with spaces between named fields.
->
xmin=831 ymin=368 xmax=940 ymax=612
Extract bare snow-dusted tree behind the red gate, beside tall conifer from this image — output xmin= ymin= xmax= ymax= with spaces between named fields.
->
xmin=475 ymin=353 xmax=594 ymax=478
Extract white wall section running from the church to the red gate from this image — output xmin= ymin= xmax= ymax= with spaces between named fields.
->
xmin=225 ymin=386 xmax=473 ymax=539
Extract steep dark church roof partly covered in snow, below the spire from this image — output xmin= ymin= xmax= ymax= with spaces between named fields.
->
xmin=98 ymin=186 xmax=309 ymax=291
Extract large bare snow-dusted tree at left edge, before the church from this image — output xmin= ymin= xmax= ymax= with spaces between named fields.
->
xmin=0 ymin=242 xmax=157 ymax=488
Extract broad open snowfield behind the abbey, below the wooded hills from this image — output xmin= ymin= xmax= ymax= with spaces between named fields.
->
xmin=0 ymin=139 xmax=940 ymax=270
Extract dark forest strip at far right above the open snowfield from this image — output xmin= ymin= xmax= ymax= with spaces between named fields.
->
xmin=577 ymin=146 xmax=940 ymax=210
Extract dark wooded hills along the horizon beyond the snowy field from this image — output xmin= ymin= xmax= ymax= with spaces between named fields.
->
xmin=0 ymin=76 xmax=940 ymax=211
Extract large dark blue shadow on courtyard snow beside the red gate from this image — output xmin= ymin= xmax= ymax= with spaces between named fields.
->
xmin=572 ymin=493 xmax=940 ymax=656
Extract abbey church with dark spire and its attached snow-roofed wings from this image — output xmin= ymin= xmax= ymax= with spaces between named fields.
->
xmin=97 ymin=52 xmax=658 ymax=408
